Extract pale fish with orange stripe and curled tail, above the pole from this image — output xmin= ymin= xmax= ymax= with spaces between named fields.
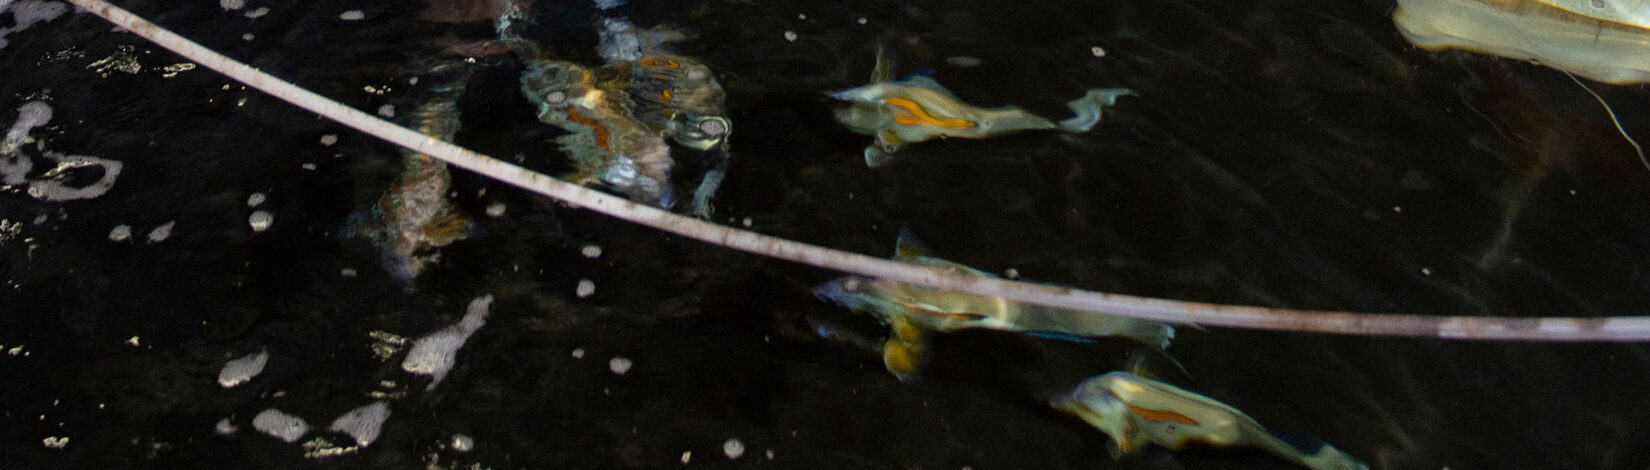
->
xmin=830 ymin=46 xmax=1134 ymax=168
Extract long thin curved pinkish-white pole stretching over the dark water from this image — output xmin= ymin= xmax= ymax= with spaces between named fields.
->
xmin=68 ymin=0 xmax=1650 ymax=341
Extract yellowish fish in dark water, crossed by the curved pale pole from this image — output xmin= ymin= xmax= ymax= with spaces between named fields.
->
xmin=813 ymin=231 xmax=1175 ymax=379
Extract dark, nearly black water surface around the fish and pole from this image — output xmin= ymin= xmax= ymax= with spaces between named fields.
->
xmin=0 ymin=0 xmax=1650 ymax=468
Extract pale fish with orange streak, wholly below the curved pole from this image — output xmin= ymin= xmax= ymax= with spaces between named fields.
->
xmin=1049 ymin=373 xmax=1370 ymax=470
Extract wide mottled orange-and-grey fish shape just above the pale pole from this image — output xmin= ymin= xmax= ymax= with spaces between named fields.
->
xmin=497 ymin=0 xmax=733 ymax=216
